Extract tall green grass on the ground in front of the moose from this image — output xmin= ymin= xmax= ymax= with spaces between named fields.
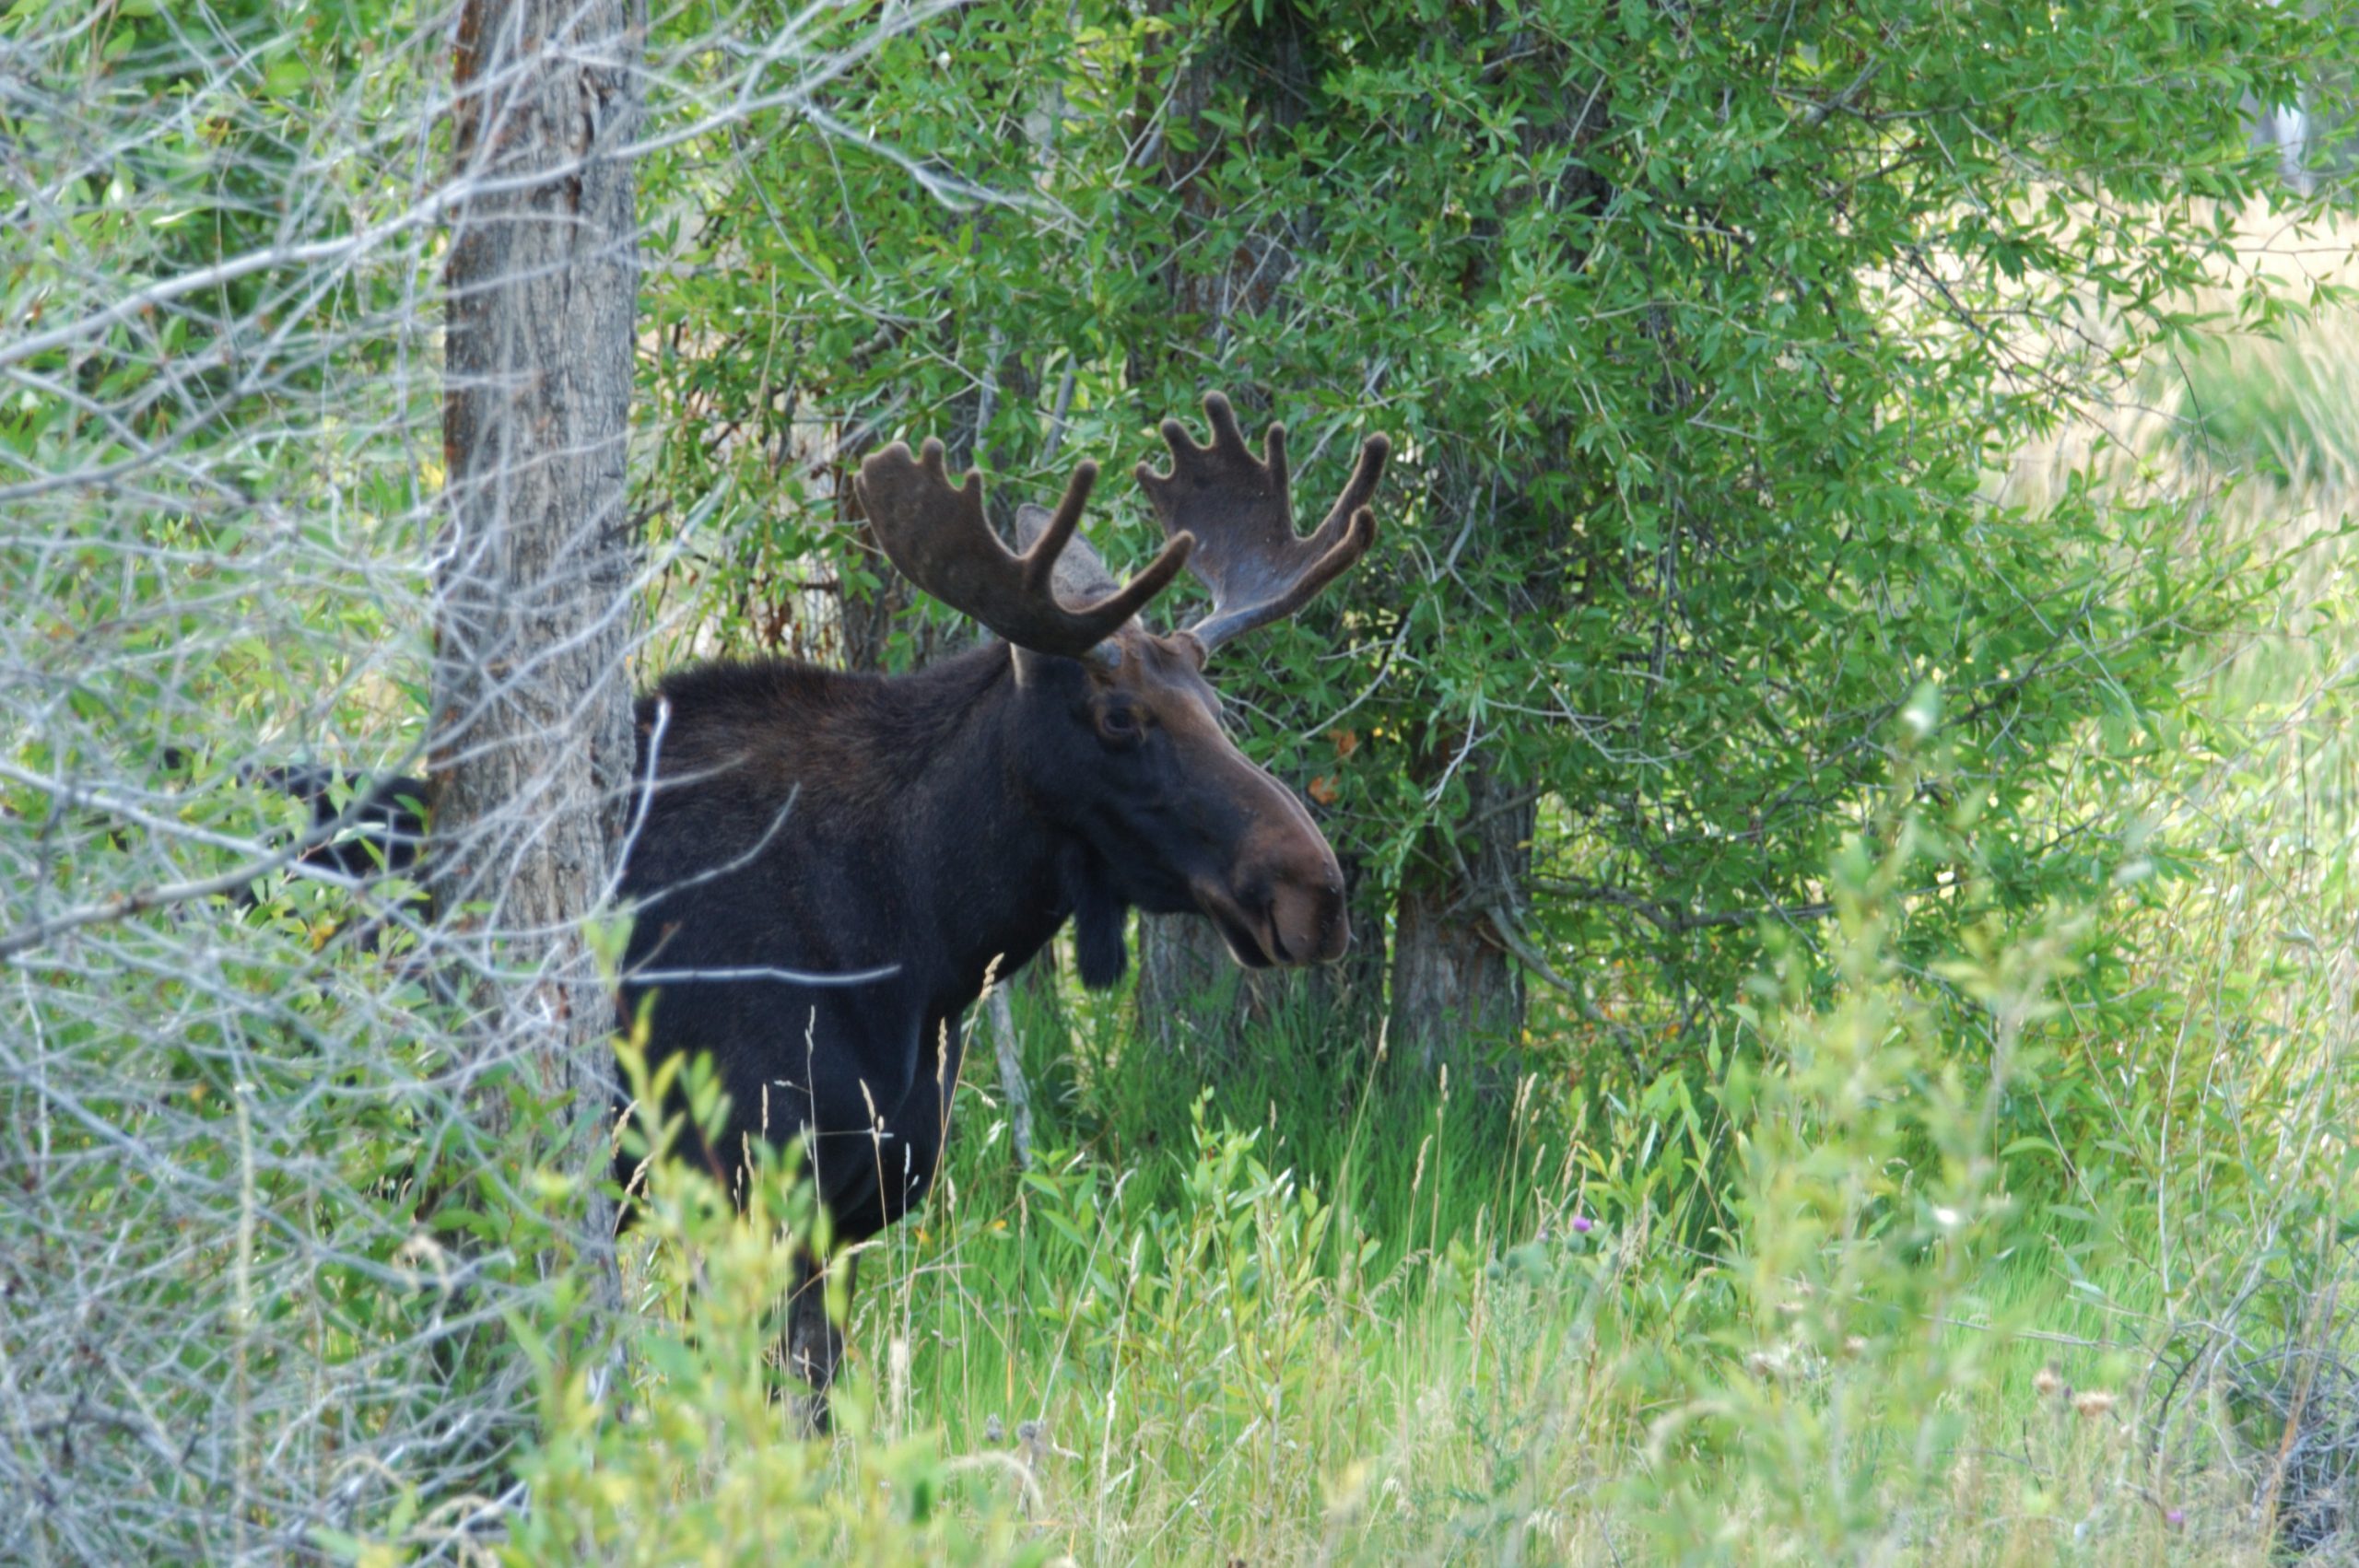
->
xmin=531 ymin=1009 xmax=2283 ymax=1563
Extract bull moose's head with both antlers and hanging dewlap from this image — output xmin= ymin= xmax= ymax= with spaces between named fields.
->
xmin=856 ymin=392 xmax=1391 ymax=986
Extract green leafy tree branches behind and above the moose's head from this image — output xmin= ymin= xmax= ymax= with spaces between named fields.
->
xmin=641 ymin=0 xmax=2350 ymax=1087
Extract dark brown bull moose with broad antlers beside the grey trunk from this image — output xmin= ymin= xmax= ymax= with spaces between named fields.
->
xmin=283 ymin=392 xmax=1390 ymax=1426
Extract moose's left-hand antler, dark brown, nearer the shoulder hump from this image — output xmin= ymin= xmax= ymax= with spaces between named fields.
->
xmin=851 ymin=441 xmax=1196 ymax=658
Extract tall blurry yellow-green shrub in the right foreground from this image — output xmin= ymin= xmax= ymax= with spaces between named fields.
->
xmin=1659 ymin=768 xmax=2071 ymax=1554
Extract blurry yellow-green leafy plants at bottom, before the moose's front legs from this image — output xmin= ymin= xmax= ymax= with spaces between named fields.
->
xmin=487 ymin=1163 xmax=1050 ymax=1568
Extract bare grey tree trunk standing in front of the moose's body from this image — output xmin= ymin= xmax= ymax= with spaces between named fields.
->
xmin=427 ymin=0 xmax=646 ymax=1304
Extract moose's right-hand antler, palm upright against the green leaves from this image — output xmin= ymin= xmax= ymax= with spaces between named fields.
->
xmin=1137 ymin=392 xmax=1391 ymax=653
